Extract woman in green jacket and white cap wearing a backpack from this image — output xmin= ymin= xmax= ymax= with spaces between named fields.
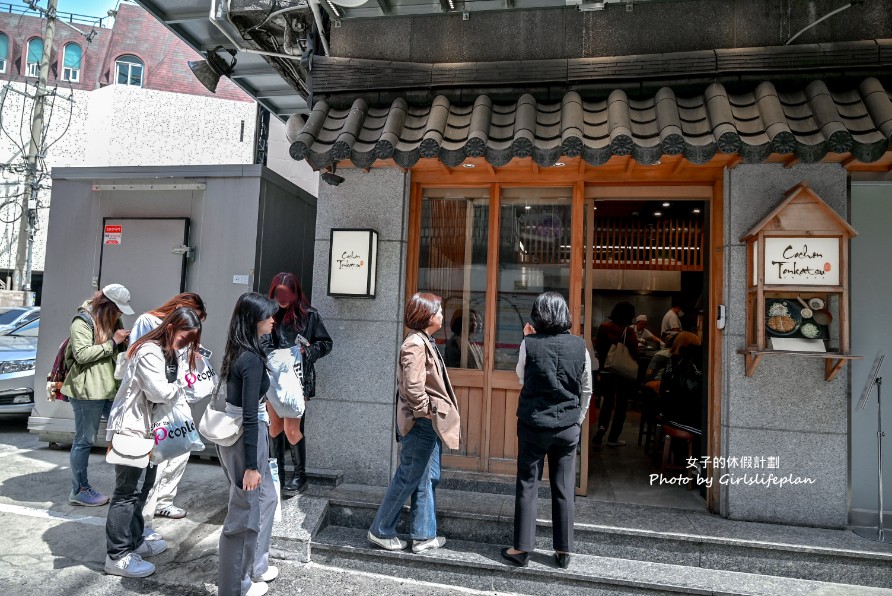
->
xmin=62 ymin=284 xmax=133 ymax=507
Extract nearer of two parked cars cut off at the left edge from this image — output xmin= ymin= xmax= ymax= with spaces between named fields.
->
xmin=0 ymin=318 xmax=40 ymax=417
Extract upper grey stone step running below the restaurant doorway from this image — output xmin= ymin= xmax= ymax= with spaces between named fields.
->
xmin=304 ymin=485 xmax=892 ymax=587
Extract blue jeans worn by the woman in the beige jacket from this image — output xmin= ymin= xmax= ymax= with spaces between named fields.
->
xmin=370 ymin=418 xmax=442 ymax=540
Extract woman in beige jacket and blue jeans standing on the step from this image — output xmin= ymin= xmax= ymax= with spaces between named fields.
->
xmin=368 ymin=293 xmax=461 ymax=553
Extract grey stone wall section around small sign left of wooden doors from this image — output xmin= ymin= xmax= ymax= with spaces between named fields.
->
xmin=306 ymin=168 xmax=408 ymax=485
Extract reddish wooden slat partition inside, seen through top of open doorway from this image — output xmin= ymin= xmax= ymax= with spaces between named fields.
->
xmin=592 ymin=217 xmax=706 ymax=271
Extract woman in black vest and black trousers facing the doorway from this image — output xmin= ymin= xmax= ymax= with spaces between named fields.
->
xmin=502 ymin=292 xmax=592 ymax=568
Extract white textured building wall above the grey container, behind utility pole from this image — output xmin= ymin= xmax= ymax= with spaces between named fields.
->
xmin=0 ymin=83 xmax=258 ymax=271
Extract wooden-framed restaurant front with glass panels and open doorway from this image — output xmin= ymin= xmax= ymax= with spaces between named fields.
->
xmin=406 ymin=178 xmax=715 ymax=507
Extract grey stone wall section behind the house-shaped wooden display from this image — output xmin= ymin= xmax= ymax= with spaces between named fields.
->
xmin=721 ymin=164 xmax=848 ymax=528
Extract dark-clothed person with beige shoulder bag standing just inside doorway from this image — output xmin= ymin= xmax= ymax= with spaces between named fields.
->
xmin=592 ymin=302 xmax=638 ymax=447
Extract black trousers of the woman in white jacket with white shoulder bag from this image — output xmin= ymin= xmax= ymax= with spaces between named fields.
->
xmin=105 ymin=464 xmax=158 ymax=561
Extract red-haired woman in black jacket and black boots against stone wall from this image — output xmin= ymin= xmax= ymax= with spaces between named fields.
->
xmin=267 ymin=272 xmax=332 ymax=493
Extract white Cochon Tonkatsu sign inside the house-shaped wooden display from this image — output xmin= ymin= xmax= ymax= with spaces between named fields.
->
xmin=765 ymin=236 xmax=840 ymax=286
